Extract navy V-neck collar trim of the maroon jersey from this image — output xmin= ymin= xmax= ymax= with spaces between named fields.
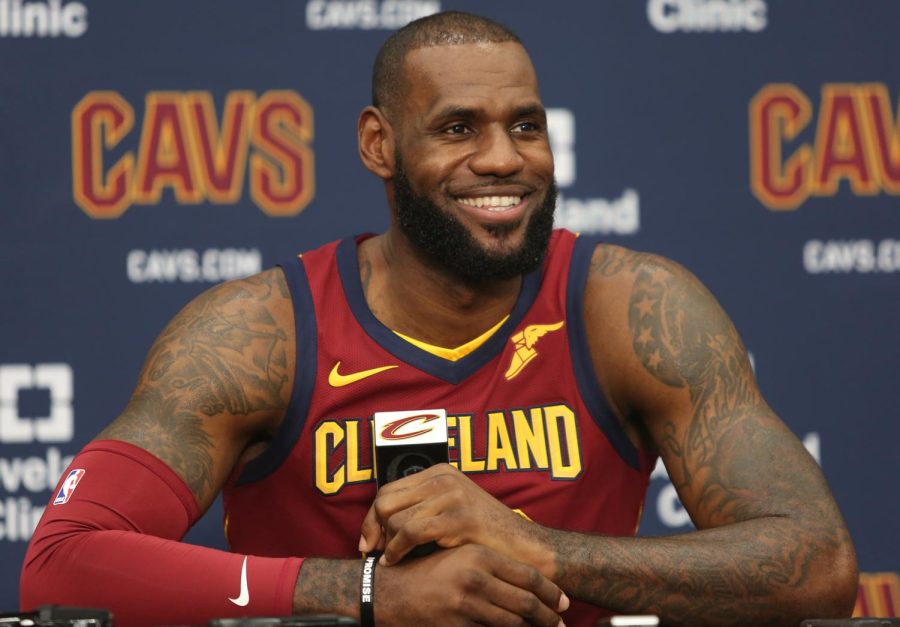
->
xmin=336 ymin=237 xmax=543 ymax=385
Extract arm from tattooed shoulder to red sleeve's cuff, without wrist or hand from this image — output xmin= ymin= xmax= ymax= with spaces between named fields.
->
xmin=20 ymin=270 xmax=330 ymax=625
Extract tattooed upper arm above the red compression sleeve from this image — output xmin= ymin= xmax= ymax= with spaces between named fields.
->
xmin=99 ymin=270 xmax=291 ymax=503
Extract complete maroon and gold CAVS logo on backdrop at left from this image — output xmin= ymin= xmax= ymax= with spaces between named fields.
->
xmin=72 ymin=90 xmax=315 ymax=218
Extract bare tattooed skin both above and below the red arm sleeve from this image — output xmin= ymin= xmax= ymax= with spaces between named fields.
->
xmin=91 ymin=269 xmax=384 ymax=616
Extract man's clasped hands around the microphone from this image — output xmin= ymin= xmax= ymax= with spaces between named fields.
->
xmin=359 ymin=464 xmax=569 ymax=627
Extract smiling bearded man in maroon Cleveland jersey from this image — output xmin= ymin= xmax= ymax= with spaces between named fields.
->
xmin=21 ymin=13 xmax=856 ymax=626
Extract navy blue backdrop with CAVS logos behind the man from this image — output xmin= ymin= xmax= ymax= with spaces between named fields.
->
xmin=0 ymin=0 xmax=900 ymax=610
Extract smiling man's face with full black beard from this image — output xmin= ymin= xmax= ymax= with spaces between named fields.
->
xmin=392 ymin=43 xmax=555 ymax=281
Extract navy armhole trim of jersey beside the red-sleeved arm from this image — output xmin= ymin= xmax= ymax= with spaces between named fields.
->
xmin=237 ymin=258 xmax=318 ymax=485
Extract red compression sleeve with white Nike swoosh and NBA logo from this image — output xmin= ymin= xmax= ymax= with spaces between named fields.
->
xmin=20 ymin=440 xmax=303 ymax=627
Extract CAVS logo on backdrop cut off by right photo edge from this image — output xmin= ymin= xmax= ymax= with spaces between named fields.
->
xmin=750 ymin=83 xmax=900 ymax=210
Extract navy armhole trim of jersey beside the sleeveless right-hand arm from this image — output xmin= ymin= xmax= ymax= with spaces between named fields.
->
xmin=566 ymin=236 xmax=641 ymax=470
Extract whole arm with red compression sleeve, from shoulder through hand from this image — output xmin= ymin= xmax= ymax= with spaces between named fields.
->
xmin=20 ymin=270 xmax=568 ymax=626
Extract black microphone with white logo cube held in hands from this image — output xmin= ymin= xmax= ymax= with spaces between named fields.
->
xmin=372 ymin=409 xmax=450 ymax=557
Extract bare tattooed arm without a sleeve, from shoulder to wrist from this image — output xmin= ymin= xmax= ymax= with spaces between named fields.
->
xmin=548 ymin=245 xmax=857 ymax=625
